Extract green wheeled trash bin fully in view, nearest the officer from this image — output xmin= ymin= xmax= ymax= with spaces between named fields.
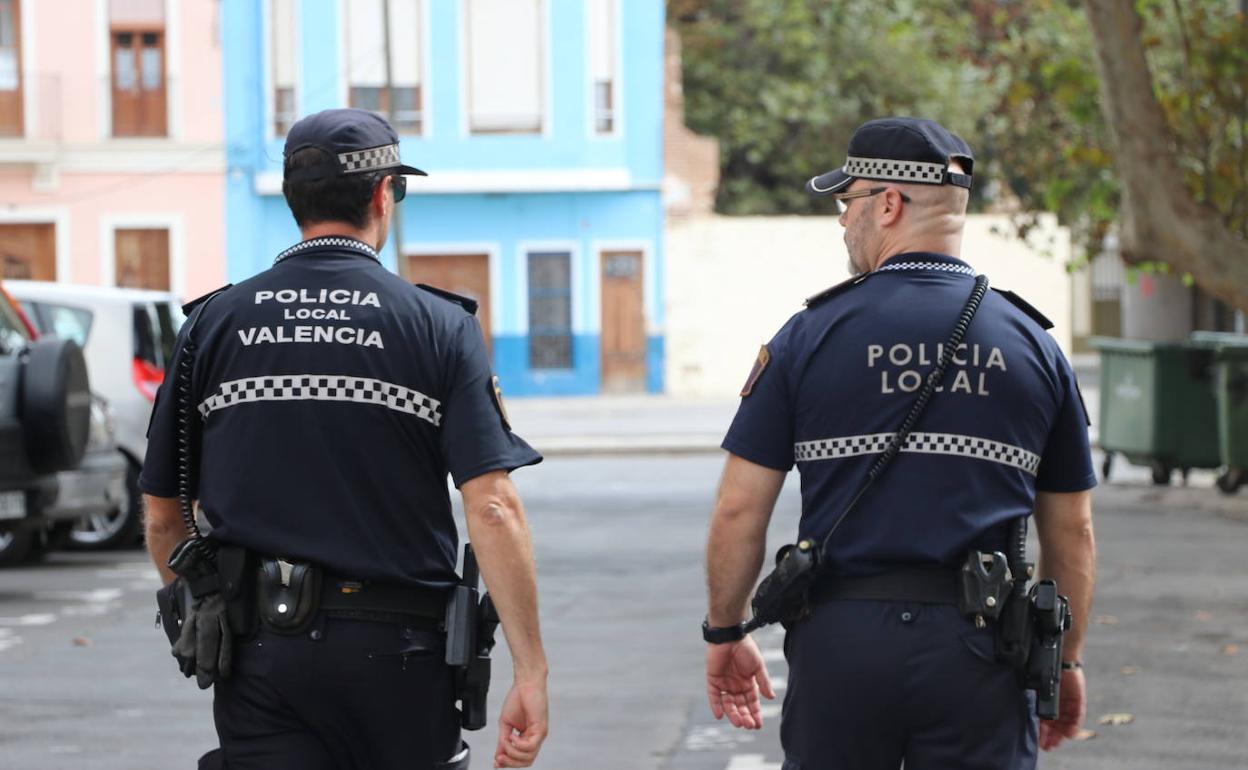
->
xmin=1091 ymin=337 xmax=1222 ymax=484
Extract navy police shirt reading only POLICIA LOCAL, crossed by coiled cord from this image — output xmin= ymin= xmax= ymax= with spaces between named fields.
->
xmin=723 ymin=253 xmax=1096 ymax=575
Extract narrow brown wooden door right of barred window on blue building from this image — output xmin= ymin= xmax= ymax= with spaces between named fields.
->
xmin=602 ymin=251 xmax=645 ymax=393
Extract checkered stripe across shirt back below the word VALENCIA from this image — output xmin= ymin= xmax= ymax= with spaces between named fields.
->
xmin=200 ymin=374 xmax=442 ymax=426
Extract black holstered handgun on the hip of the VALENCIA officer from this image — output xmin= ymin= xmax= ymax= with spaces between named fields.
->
xmin=446 ymin=544 xmax=499 ymax=730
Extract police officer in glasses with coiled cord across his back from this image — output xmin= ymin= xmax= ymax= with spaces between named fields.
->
xmin=704 ymin=117 xmax=1096 ymax=770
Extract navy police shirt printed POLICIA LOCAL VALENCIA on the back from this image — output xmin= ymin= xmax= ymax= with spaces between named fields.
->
xmin=139 ymin=237 xmax=542 ymax=588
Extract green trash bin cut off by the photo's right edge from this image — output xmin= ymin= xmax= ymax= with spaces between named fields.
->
xmin=1192 ymin=332 xmax=1248 ymax=494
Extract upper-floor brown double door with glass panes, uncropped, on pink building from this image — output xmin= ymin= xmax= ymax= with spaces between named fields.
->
xmin=112 ymin=27 xmax=167 ymax=136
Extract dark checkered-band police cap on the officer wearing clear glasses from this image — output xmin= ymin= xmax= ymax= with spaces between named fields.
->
xmin=806 ymin=117 xmax=975 ymax=196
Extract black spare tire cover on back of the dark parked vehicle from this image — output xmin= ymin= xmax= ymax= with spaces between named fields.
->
xmin=21 ymin=337 xmax=91 ymax=473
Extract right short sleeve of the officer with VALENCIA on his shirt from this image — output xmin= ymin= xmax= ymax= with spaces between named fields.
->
xmin=441 ymin=316 xmax=542 ymax=487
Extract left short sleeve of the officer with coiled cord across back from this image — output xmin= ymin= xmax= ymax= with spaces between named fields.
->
xmin=720 ymin=321 xmax=794 ymax=470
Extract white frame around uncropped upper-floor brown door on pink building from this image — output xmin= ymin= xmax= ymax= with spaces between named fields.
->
xmin=94 ymin=0 xmax=179 ymax=142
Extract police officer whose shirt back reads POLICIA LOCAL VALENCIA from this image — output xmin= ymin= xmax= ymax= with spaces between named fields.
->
xmin=140 ymin=110 xmax=547 ymax=770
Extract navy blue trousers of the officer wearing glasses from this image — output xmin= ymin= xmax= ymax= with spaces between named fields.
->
xmin=780 ymin=600 xmax=1037 ymax=770
